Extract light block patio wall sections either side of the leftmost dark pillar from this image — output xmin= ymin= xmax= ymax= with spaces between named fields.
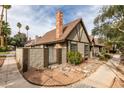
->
xmin=16 ymin=48 xmax=44 ymax=70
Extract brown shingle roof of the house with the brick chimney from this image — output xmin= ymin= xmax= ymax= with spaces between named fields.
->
xmin=25 ymin=18 xmax=90 ymax=45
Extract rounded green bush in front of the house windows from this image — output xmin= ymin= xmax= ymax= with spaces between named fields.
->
xmin=67 ymin=51 xmax=83 ymax=65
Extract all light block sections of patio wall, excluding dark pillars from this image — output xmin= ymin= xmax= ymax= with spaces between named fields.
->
xmin=16 ymin=47 xmax=67 ymax=70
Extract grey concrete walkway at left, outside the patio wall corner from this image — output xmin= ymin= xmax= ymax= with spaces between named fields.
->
xmin=0 ymin=57 xmax=40 ymax=88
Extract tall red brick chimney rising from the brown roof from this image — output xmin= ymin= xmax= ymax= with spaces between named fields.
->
xmin=56 ymin=10 xmax=63 ymax=39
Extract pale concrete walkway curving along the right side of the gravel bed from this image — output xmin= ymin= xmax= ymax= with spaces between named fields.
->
xmin=70 ymin=55 xmax=120 ymax=88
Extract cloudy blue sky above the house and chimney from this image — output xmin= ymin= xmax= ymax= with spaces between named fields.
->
xmin=0 ymin=5 xmax=102 ymax=38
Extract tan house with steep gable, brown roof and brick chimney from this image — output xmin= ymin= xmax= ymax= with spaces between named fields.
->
xmin=26 ymin=11 xmax=104 ymax=58
